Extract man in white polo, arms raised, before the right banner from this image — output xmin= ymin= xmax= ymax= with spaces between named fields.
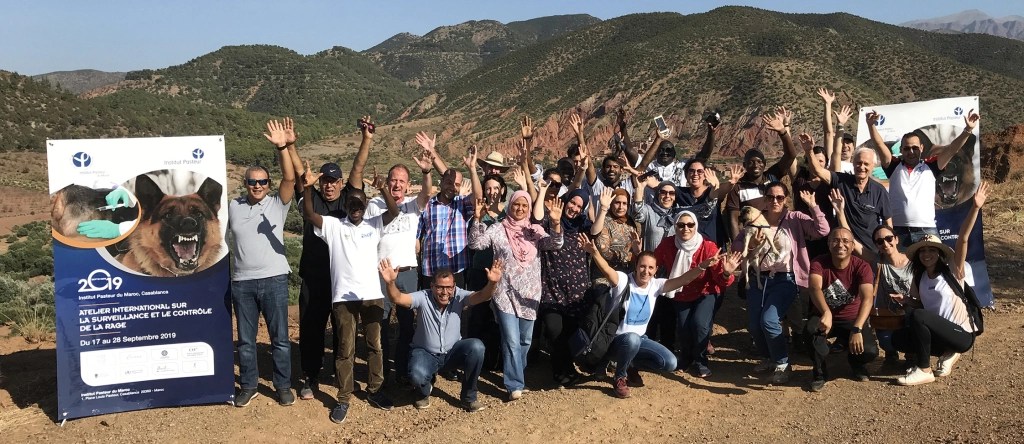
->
xmin=865 ymin=109 xmax=981 ymax=246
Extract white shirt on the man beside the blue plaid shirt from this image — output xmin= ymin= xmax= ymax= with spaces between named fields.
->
xmin=366 ymin=195 xmax=420 ymax=267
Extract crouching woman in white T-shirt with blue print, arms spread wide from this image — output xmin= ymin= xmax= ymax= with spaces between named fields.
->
xmin=580 ymin=236 xmax=740 ymax=398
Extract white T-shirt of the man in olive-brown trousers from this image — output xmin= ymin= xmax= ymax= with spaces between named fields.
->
xmin=313 ymin=216 xmax=384 ymax=302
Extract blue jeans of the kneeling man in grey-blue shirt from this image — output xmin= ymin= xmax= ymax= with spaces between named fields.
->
xmin=409 ymin=338 xmax=483 ymax=402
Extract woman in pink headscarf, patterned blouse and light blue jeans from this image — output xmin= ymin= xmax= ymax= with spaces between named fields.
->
xmin=469 ymin=190 xmax=562 ymax=400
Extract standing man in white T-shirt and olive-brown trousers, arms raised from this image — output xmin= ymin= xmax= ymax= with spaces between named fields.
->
xmin=302 ymin=117 xmax=399 ymax=424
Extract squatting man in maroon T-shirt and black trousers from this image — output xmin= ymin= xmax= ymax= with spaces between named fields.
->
xmin=807 ymin=228 xmax=879 ymax=392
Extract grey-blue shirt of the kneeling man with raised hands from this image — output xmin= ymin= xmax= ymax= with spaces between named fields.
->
xmin=410 ymin=286 xmax=472 ymax=353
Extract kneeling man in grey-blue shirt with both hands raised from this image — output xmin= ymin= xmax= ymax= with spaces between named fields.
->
xmin=378 ymin=259 xmax=503 ymax=412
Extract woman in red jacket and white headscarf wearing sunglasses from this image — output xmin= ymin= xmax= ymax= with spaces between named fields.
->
xmin=654 ymin=211 xmax=733 ymax=378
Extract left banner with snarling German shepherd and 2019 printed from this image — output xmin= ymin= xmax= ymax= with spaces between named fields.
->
xmin=46 ymin=136 xmax=234 ymax=420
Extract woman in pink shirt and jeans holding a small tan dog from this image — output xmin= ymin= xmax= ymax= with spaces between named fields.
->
xmin=732 ymin=181 xmax=828 ymax=385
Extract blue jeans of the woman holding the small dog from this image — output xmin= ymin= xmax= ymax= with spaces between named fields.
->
xmin=746 ymin=273 xmax=799 ymax=365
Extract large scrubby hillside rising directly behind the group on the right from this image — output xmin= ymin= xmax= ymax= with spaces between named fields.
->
xmin=404 ymin=7 xmax=1024 ymax=154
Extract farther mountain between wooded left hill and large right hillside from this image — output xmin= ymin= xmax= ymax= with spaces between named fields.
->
xmin=364 ymin=14 xmax=601 ymax=90
